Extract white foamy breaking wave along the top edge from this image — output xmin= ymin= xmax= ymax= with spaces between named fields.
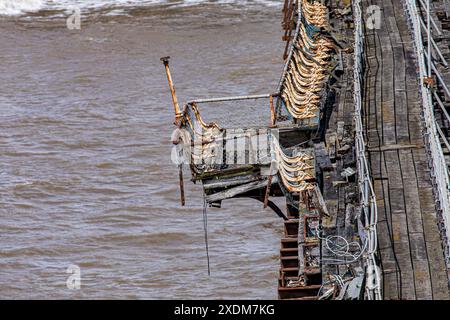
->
xmin=0 ymin=0 xmax=281 ymax=16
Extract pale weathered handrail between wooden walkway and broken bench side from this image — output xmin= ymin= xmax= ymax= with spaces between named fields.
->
xmin=353 ymin=0 xmax=382 ymax=300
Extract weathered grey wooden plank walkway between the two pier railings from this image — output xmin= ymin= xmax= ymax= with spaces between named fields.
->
xmin=363 ymin=0 xmax=449 ymax=299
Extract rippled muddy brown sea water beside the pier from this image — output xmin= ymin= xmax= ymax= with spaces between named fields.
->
xmin=0 ymin=4 xmax=283 ymax=299
